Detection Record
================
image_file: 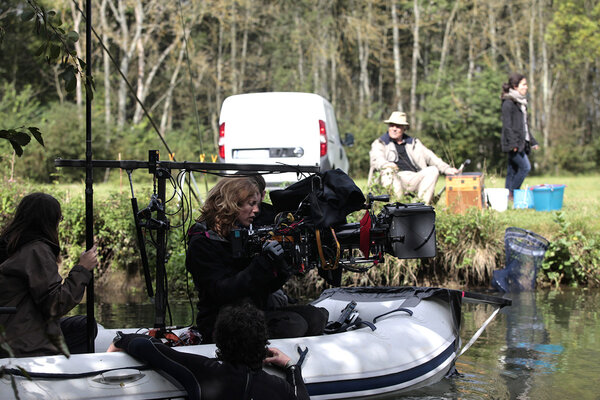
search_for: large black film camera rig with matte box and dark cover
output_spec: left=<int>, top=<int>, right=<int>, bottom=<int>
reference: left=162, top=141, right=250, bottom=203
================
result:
left=231, top=170, right=436, bottom=285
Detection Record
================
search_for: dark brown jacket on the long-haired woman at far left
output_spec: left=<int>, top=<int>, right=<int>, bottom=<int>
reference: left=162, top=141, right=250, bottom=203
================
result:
left=0, top=240, right=92, bottom=357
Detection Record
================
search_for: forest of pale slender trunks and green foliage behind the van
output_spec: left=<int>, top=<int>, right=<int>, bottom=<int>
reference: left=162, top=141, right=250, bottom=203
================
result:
left=0, top=0, right=600, bottom=296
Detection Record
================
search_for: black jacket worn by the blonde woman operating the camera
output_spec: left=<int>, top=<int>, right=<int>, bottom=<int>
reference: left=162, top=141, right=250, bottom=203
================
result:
left=185, top=223, right=288, bottom=343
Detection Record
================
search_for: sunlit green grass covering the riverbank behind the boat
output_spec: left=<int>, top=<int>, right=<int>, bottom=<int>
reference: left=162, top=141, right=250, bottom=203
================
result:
left=10, top=171, right=600, bottom=290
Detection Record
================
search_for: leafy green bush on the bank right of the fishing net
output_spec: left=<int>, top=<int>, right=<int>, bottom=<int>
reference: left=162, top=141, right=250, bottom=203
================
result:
left=542, top=212, right=600, bottom=286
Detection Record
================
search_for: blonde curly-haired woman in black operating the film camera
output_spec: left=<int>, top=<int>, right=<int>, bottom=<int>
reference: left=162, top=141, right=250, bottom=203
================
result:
left=186, top=177, right=329, bottom=343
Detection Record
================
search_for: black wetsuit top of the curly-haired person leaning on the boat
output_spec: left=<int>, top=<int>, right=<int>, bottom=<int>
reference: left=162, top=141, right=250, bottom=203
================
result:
left=115, top=335, right=309, bottom=400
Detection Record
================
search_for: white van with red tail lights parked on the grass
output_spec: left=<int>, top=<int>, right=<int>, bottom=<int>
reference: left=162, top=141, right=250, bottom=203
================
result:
left=219, top=92, right=354, bottom=188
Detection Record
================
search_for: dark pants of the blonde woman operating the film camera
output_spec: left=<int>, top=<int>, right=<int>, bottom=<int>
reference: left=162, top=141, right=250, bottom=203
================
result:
left=265, top=305, right=329, bottom=339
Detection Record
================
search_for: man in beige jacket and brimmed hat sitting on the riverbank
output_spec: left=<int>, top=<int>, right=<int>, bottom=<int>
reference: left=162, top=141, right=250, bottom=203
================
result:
left=369, top=111, right=458, bottom=204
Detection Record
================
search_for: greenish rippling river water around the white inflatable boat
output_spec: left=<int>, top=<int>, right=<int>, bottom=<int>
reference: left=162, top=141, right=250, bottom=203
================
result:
left=79, top=289, right=600, bottom=400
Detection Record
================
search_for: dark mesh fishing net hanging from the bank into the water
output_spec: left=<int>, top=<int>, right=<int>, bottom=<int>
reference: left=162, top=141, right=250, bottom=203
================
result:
left=492, top=227, right=549, bottom=292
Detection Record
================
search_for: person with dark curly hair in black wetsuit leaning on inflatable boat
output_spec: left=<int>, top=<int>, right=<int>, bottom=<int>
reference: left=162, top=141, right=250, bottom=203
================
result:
left=108, top=304, right=309, bottom=400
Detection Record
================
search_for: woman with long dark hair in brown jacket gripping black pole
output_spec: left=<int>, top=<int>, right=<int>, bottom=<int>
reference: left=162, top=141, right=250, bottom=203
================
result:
left=0, top=193, right=98, bottom=357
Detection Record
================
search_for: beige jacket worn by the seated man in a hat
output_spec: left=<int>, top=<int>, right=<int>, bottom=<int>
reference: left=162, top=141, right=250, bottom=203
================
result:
left=369, top=132, right=450, bottom=174
